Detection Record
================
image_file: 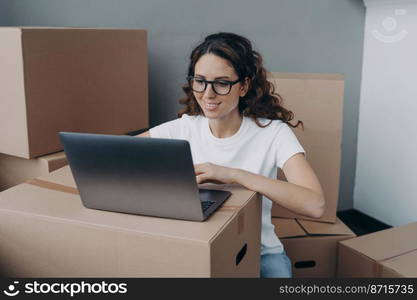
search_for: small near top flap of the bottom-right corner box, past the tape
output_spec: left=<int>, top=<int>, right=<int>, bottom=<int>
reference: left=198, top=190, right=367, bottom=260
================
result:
left=381, top=251, right=417, bottom=278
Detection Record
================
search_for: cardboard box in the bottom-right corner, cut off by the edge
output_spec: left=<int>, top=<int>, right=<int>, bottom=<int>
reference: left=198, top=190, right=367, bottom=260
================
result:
left=337, top=222, right=417, bottom=278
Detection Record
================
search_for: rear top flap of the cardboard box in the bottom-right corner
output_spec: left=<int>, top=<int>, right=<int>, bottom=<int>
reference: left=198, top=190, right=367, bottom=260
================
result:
left=341, top=222, right=417, bottom=261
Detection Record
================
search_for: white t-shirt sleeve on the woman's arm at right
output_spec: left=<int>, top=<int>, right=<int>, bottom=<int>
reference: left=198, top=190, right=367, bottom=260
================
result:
left=276, top=124, right=306, bottom=169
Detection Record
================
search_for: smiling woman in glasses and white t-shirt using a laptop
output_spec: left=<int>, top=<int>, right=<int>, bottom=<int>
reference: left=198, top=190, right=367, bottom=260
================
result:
left=140, top=33, right=325, bottom=277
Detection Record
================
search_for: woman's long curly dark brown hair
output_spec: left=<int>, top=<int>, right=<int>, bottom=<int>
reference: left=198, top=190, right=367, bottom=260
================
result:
left=178, top=32, right=304, bottom=129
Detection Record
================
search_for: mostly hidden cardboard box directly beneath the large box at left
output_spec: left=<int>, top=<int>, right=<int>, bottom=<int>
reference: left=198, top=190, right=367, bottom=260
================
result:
left=0, top=151, right=68, bottom=192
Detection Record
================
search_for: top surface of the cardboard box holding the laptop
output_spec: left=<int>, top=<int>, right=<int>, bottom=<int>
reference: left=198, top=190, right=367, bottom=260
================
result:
left=0, top=166, right=257, bottom=243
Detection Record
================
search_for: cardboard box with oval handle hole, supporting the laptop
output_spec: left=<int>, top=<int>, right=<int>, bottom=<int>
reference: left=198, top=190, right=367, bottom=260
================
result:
left=0, top=166, right=261, bottom=277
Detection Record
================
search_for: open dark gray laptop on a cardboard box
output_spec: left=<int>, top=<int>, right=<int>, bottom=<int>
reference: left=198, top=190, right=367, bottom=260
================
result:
left=59, top=132, right=231, bottom=221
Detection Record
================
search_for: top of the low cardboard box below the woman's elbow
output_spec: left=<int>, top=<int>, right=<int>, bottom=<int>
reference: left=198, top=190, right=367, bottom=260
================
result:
left=272, top=218, right=355, bottom=238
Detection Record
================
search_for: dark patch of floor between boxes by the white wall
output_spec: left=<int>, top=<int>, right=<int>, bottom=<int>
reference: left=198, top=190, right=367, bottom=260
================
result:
left=337, top=209, right=392, bottom=236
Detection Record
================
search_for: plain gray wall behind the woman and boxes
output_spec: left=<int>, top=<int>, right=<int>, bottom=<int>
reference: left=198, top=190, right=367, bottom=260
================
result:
left=2, top=0, right=365, bottom=210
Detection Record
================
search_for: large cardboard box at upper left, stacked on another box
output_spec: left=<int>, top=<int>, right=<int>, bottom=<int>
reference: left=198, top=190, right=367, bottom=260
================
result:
left=0, top=27, right=149, bottom=158
